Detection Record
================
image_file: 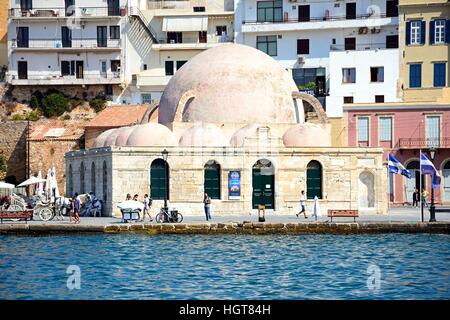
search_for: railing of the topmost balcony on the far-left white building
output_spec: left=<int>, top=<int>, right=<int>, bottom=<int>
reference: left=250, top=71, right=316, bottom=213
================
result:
left=9, top=6, right=127, bottom=18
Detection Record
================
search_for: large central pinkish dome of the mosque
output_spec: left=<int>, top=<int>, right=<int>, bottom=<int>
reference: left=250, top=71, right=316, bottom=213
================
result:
left=158, top=44, right=304, bottom=123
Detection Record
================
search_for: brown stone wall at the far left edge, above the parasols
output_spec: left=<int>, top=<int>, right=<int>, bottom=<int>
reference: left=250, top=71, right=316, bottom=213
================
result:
left=0, top=121, right=27, bottom=182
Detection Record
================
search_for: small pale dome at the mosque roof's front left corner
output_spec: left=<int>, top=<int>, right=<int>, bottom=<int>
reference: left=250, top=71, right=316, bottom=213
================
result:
left=126, top=123, right=178, bottom=147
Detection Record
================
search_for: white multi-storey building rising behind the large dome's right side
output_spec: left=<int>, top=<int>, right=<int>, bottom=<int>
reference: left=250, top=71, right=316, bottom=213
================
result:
left=235, top=0, right=398, bottom=117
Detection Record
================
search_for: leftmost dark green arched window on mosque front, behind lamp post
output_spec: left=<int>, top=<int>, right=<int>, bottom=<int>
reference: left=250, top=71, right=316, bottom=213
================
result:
left=150, top=159, right=170, bottom=200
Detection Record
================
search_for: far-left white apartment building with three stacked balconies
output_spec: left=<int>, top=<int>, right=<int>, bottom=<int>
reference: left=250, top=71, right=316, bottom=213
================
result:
left=7, top=0, right=127, bottom=95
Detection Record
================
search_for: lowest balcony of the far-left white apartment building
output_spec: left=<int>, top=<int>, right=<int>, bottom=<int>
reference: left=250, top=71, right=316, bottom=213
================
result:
left=6, top=72, right=122, bottom=86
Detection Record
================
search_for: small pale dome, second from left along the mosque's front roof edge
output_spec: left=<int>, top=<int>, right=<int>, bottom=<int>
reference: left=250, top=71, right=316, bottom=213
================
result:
left=180, top=123, right=230, bottom=147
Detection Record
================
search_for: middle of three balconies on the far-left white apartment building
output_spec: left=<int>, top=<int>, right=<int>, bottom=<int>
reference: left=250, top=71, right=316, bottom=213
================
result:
left=11, top=38, right=122, bottom=52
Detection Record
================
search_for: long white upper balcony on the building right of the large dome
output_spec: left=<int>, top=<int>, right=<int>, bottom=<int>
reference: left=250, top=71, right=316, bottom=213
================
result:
left=242, top=14, right=398, bottom=33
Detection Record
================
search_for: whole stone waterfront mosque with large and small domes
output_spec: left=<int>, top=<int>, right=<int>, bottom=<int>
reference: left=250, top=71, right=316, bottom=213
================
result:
left=66, top=44, right=387, bottom=216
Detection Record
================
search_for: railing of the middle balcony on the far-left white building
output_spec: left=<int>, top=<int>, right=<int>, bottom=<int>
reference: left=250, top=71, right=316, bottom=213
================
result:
left=11, top=38, right=121, bottom=49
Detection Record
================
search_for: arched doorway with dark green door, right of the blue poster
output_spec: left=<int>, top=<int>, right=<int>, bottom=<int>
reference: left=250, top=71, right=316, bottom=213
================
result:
left=252, top=159, right=275, bottom=209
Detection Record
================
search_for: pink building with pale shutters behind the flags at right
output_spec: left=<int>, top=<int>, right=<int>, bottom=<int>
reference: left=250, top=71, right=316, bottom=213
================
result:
left=344, top=103, right=450, bottom=205
